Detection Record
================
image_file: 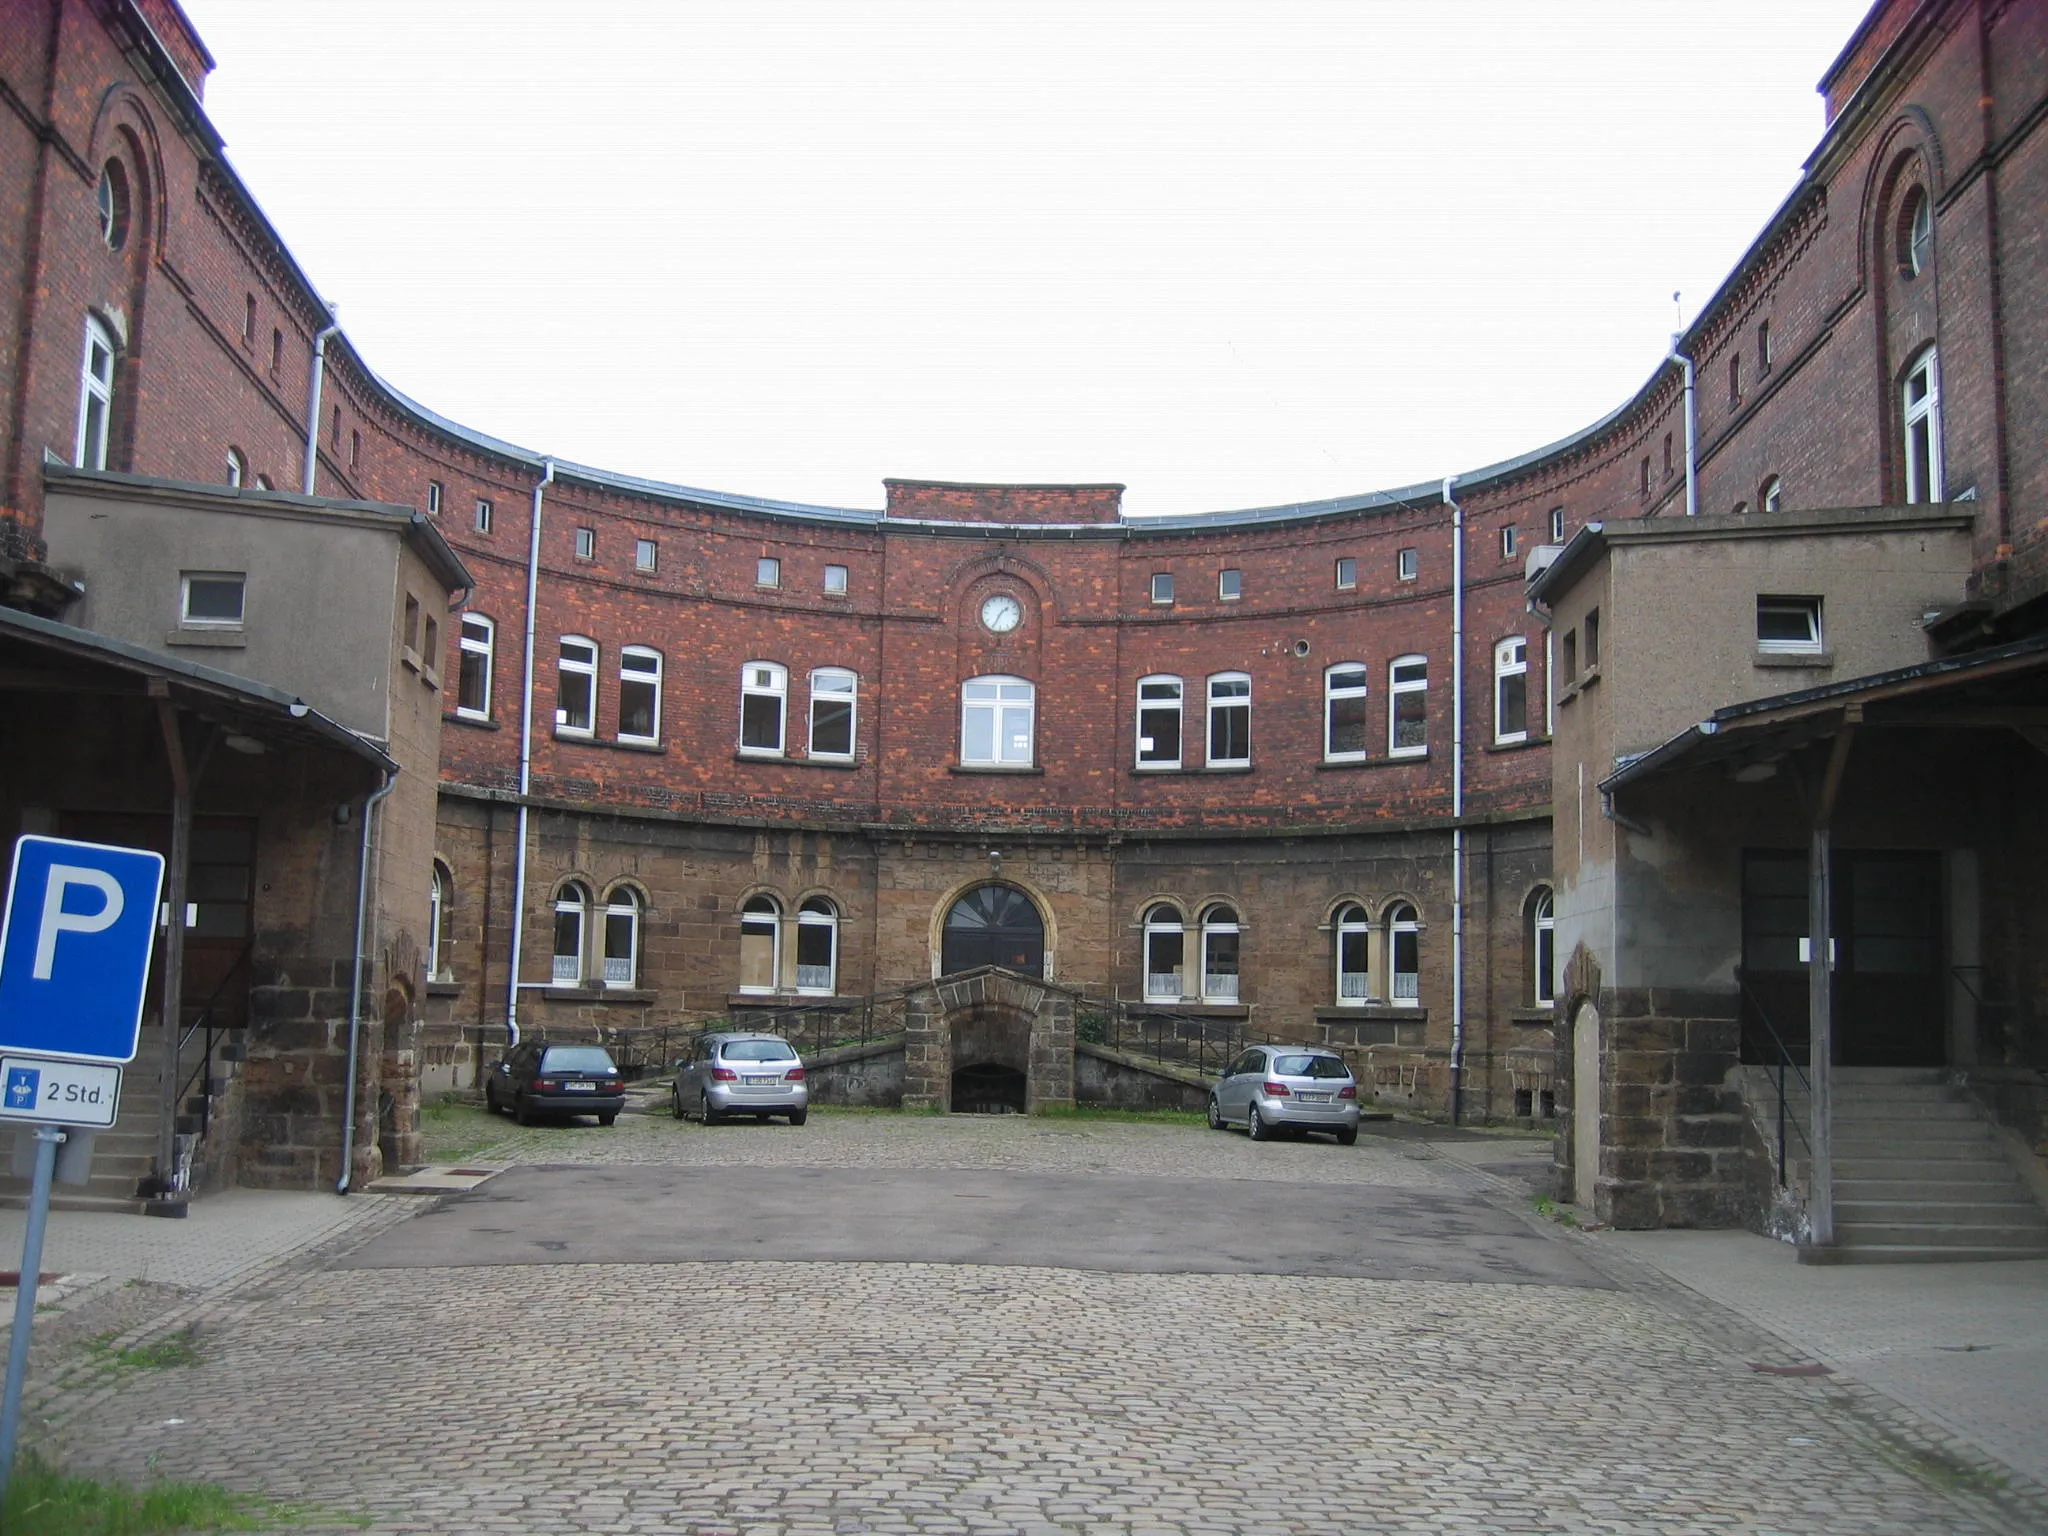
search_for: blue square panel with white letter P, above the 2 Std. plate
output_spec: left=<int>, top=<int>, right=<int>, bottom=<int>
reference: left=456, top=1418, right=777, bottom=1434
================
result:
left=0, top=836, right=164, bottom=1094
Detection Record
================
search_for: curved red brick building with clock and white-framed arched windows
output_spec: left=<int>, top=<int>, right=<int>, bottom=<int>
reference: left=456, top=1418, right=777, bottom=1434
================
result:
left=0, top=0, right=2048, bottom=1179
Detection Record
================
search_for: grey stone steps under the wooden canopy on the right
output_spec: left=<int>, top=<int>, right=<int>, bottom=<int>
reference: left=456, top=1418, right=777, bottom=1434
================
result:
left=1835, top=1067, right=2048, bottom=1264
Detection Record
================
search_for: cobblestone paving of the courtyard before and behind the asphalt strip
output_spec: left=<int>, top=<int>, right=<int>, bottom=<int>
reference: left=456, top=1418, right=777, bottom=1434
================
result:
left=19, top=1114, right=2040, bottom=1536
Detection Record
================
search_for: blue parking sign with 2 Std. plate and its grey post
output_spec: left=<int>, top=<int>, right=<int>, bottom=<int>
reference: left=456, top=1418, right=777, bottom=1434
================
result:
left=0, top=836, right=163, bottom=1495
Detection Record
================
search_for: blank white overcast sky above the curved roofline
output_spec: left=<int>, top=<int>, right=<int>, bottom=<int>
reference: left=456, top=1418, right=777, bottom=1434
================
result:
left=184, top=0, right=1868, bottom=512
